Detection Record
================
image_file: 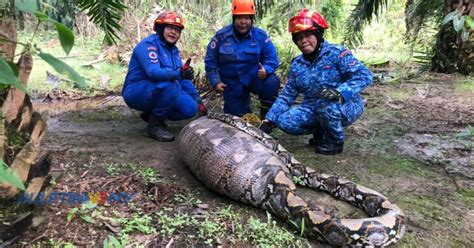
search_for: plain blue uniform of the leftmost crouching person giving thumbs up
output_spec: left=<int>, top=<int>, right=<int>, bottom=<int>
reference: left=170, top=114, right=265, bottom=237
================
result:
left=122, top=34, right=200, bottom=120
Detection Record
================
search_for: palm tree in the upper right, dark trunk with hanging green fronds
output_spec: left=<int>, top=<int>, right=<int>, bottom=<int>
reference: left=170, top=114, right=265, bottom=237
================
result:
left=344, top=0, right=474, bottom=75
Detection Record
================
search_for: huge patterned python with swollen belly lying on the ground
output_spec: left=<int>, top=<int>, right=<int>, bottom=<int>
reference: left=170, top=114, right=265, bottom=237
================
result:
left=178, top=112, right=405, bottom=247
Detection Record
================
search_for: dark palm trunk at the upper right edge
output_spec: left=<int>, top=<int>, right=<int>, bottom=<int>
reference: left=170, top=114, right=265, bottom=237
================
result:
left=432, top=0, right=474, bottom=75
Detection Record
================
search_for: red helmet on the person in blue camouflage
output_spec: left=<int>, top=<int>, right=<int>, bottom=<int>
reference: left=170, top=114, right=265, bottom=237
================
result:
left=288, top=9, right=328, bottom=34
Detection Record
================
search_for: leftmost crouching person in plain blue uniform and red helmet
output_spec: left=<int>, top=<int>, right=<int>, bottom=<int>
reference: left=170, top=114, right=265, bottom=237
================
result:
left=122, top=11, right=205, bottom=142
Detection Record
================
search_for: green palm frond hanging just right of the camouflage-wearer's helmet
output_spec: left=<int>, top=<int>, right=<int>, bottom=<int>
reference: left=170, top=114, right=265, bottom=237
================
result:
left=344, top=0, right=388, bottom=48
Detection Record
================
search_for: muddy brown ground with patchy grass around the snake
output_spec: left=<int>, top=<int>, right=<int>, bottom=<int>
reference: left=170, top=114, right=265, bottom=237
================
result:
left=8, top=74, right=474, bottom=247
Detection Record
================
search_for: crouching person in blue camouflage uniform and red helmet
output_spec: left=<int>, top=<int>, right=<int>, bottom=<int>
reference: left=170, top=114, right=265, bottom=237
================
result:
left=260, top=9, right=372, bottom=155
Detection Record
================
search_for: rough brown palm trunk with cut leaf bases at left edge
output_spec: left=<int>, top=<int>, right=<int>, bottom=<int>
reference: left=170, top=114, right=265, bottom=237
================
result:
left=0, top=18, right=46, bottom=199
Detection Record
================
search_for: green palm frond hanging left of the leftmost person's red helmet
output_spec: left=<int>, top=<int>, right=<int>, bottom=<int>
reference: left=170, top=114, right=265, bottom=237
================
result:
left=77, top=0, right=127, bottom=45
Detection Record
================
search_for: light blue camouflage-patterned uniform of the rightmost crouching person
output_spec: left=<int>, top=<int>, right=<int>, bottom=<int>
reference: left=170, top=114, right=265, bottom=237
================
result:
left=266, top=41, right=372, bottom=144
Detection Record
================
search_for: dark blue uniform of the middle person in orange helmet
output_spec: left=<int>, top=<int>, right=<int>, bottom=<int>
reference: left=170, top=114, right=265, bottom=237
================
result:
left=205, top=25, right=280, bottom=116
